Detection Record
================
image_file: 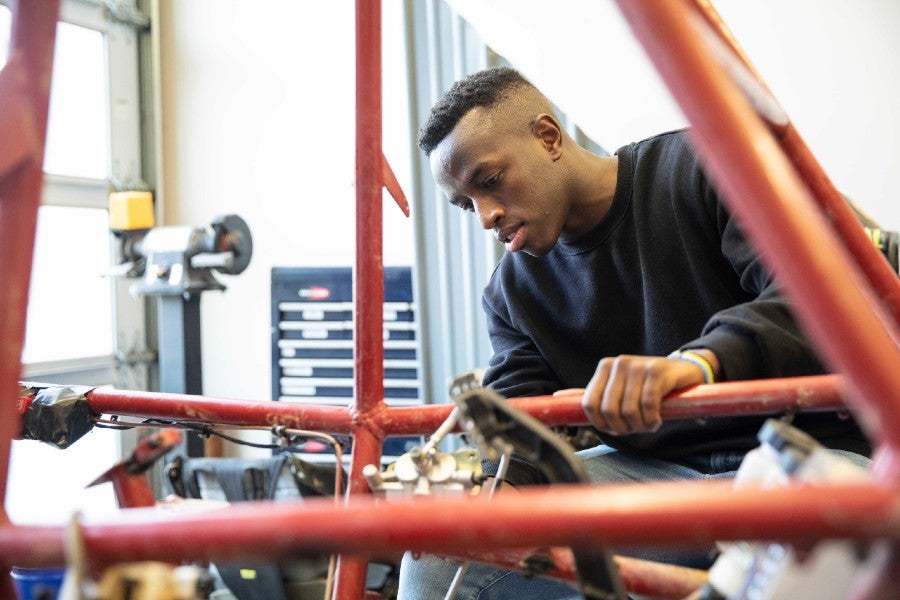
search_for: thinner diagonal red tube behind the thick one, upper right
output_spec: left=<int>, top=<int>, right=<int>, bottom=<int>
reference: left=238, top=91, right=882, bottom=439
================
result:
left=694, top=0, right=900, bottom=323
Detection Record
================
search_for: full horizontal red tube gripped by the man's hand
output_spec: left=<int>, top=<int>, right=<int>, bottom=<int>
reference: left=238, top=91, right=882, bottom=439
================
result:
left=75, top=375, right=846, bottom=438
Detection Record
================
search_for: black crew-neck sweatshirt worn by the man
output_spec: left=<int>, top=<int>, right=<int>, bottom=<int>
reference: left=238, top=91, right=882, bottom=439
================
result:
left=483, top=131, right=869, bottom=458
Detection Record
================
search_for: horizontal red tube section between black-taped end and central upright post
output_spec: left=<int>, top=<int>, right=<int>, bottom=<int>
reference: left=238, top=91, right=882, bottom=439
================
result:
left=86, top=388, right=353, bottom=433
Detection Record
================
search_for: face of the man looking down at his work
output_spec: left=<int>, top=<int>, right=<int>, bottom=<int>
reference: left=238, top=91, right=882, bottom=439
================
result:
left=430, top=108, right=566, bottom=256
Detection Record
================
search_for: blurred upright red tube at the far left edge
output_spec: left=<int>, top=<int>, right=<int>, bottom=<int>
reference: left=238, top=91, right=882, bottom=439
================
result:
left=0, top=0, right=59, bottom=520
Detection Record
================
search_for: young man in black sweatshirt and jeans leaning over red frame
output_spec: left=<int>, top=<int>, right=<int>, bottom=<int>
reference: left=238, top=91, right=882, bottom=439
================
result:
left=401, top=68, right=869, bottom=598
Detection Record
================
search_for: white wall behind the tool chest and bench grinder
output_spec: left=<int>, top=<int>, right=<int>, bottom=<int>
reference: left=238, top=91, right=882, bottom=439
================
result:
left=158, top=0, right=413, bottom=426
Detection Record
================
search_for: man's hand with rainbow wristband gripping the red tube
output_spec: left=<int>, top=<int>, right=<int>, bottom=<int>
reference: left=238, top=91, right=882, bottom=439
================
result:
left=581, top=350, right=719, bottom=435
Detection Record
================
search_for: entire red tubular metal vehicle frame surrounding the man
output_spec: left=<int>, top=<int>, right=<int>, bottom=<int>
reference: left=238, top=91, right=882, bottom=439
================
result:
left=0, top=0, right=900, bottom=600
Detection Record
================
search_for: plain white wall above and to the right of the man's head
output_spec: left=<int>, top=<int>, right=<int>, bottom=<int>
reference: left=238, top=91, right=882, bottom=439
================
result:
left=448, top=0, right=900, bottom=229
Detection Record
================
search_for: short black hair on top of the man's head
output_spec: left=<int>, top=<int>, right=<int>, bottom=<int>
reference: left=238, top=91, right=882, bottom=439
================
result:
left=419, top=67, right=534, bottom=156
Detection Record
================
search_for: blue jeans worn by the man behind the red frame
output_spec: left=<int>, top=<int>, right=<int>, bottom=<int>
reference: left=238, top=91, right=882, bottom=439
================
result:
left=398, top=446, right=868, bottom=600
